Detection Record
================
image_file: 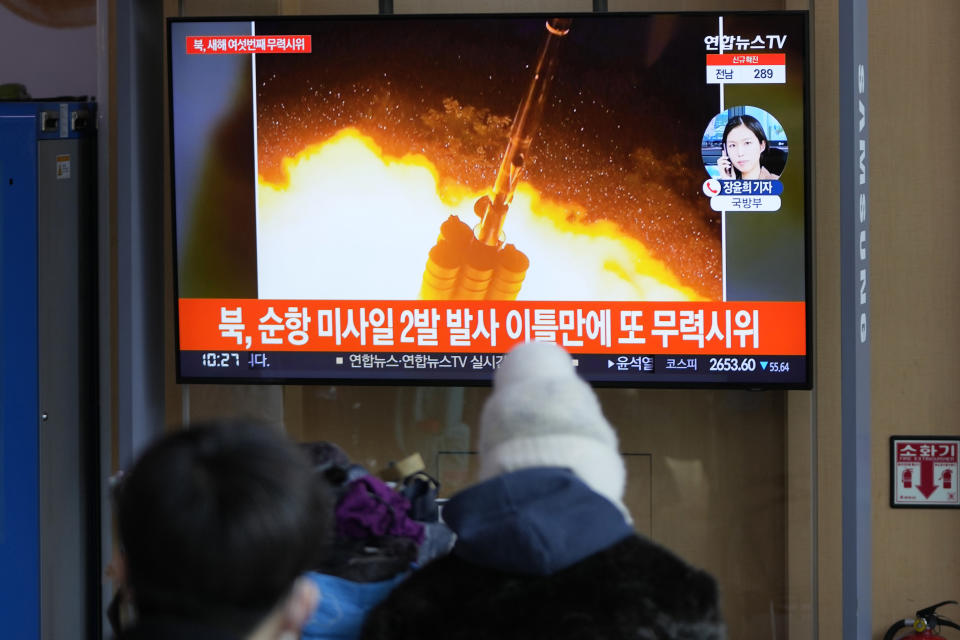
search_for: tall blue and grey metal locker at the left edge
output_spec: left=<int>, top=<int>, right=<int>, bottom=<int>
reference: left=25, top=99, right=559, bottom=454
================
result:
left=0, top=102, right=99, bottom=639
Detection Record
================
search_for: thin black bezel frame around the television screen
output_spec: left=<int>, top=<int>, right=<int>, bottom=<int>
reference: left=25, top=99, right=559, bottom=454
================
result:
left=164, top=9, right=815, bottom=391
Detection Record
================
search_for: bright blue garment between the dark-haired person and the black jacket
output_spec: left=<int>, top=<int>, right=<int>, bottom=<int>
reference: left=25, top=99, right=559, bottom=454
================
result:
left=301, top=571, right=409, bottom=640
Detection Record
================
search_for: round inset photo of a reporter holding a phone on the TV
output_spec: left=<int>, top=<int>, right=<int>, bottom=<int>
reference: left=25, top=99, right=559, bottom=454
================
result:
left=700, top=106, right=789, bottom=180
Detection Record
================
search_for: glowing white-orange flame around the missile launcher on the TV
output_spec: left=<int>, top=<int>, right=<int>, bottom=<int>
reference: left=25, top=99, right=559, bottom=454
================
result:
left=257, top=128, right=703, bottom=301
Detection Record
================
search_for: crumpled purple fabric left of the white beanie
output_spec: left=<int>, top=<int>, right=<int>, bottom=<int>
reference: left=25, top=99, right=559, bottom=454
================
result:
left=336, top=475, right=424, bottom=544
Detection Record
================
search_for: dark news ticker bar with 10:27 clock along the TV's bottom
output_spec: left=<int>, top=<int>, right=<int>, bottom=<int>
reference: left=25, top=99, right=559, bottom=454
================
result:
left=180, top=351, right=807, bottom=385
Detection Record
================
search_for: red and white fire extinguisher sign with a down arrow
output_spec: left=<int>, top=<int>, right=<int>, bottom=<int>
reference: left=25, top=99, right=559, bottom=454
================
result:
left=890, top=436, right=960, bottom=509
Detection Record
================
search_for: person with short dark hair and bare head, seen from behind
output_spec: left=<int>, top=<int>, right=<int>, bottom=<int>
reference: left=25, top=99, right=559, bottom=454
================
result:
left=114, top=421, right=333, bottom=640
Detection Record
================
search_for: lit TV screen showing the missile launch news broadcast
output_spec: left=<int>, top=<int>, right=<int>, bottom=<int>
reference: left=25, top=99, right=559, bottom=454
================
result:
left=167, top=12, right=810, bottom=388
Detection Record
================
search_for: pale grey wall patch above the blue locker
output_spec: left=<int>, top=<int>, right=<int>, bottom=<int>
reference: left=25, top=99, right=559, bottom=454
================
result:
left=0, top=6, right=97, bottom=98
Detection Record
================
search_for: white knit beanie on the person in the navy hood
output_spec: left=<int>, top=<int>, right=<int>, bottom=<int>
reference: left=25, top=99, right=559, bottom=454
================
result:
left=479, top=342, right=630, bottom=520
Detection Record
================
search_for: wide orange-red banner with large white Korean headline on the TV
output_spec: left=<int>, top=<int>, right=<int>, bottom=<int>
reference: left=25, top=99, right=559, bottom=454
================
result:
left=179, top=299, right=806, bottom=356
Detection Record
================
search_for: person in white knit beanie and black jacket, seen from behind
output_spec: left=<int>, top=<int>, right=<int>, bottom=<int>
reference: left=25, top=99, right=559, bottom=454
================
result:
left=361, top=343, right=725, bottom=640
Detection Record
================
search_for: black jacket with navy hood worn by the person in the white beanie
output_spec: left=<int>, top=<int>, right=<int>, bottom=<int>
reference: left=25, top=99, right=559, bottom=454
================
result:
left=362, top=469, right=725, bottom=640
